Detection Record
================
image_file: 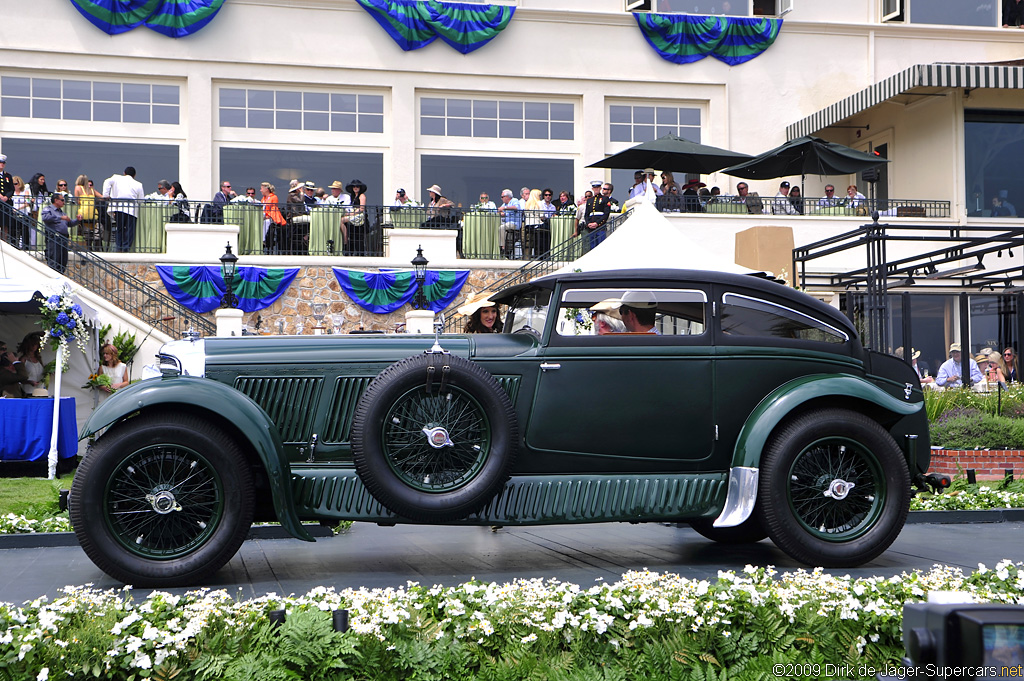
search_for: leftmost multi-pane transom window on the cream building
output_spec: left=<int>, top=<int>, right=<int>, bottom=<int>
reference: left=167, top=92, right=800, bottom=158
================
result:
left=0, top=76, right=180, bottom=125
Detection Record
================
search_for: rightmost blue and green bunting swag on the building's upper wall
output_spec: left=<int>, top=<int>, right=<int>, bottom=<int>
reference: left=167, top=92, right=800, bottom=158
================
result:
left=633, top=12, right=782, bottom=67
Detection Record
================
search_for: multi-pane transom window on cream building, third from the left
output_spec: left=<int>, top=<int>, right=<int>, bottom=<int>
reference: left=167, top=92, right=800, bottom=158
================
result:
left=420, top=97, right=575, bottom=139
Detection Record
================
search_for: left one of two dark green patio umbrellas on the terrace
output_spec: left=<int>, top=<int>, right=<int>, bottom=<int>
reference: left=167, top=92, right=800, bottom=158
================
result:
left=587, top=135, right=753, bottom=175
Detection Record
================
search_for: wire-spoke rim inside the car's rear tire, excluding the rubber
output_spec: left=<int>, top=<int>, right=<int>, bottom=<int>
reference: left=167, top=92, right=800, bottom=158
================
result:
left=788, top=437, right=886, bottom=542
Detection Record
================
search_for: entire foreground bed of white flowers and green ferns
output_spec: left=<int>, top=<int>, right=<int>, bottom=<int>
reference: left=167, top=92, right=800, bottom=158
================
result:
left=0, top=560, right=1024, bottom=681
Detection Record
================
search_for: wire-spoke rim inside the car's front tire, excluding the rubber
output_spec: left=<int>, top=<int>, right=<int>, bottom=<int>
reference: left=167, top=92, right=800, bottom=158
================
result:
left=103, top=444, right=224, bottom=558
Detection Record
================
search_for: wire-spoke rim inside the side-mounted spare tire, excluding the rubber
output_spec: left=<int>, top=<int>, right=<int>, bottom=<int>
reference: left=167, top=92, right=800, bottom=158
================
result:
left=381, top=387, right=490, bottom=492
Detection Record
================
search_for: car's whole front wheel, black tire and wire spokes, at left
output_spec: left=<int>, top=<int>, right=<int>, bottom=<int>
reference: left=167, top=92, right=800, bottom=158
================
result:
left=70, top=415, right=254, bottom=587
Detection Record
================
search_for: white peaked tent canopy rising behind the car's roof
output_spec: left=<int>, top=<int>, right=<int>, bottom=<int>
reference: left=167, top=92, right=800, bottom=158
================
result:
left=558, top=201, right=757, bottom=274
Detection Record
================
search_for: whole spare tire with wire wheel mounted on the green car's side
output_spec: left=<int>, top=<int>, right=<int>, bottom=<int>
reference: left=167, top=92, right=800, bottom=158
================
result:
left=352, top=352, right=519, bottom=521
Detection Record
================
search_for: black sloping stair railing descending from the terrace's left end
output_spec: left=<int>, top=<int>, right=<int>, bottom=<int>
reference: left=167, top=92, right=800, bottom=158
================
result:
left=0, top=203, right=216, bottom=338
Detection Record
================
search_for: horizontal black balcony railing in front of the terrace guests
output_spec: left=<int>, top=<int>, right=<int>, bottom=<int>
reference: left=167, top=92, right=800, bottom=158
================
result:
left=6, top=196, right=950, bottom=260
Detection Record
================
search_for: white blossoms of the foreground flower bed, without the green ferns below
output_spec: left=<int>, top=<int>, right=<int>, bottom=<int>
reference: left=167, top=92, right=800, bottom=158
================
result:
left=0, top=560, right=1024, bottom=679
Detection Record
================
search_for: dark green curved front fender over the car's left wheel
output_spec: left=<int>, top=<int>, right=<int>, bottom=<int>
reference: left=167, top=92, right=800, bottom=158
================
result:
left=79, top=376, right=314, bottom=542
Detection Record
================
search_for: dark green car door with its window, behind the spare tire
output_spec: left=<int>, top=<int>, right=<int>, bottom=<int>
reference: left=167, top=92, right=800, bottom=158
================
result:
left=525, top=284, right=715, bottom=471
